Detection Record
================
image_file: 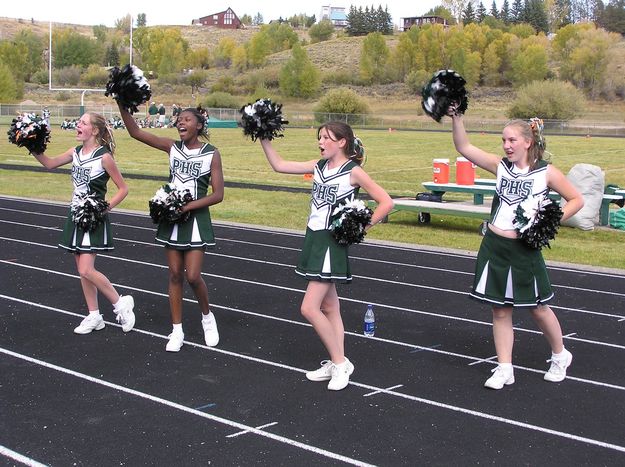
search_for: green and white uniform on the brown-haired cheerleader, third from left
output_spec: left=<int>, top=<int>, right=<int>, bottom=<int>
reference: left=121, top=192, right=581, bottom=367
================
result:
left=295, top=159, right=358, bottom=282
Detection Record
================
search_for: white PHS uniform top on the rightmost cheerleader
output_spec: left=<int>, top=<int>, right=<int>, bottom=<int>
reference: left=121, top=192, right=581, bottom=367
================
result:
left=490, top=158, right=549, bottom=230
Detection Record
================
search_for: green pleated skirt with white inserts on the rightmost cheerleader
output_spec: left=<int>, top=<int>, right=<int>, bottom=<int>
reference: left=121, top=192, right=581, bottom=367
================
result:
left=470, top=229, right=553, bottom=307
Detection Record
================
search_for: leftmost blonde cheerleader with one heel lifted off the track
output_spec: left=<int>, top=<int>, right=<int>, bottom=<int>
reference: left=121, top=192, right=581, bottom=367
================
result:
left=33, top=112, right=135, bottom=334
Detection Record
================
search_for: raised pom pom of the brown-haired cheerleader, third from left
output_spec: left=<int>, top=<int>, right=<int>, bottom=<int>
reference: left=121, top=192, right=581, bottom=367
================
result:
left=239, top=99, right=289, bottom=141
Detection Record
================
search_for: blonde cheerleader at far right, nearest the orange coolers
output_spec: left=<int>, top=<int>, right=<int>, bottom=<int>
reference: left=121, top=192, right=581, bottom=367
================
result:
left=449, top=107, right=584, bottom=389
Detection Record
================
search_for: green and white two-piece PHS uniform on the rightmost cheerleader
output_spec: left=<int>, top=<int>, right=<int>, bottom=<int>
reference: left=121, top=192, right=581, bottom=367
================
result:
left=471, top=158, right=553, bottom=307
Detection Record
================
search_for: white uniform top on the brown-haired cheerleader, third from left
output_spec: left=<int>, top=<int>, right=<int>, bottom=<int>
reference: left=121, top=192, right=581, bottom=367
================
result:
left=308, top=159, right=358, bottom=230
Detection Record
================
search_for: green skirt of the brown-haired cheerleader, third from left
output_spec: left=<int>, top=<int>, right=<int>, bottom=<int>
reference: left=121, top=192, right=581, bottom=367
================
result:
left=295, top=228, right=352, bottom=283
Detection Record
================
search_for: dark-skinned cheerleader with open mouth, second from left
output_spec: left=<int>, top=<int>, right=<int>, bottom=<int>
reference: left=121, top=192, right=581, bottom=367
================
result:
left=118, top=104, right=224, bottom=352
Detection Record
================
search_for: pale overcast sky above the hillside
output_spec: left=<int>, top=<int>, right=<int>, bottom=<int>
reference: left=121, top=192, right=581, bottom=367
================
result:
left=0, top=0, right=441, bottom=27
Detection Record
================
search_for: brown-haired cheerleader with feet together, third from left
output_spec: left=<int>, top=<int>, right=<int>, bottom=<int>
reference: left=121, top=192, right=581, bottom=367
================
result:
left=260, top=122, right=393, bottom=391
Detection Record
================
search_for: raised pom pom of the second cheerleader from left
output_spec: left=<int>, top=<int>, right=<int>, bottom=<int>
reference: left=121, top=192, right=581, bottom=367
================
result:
left=104, top=65, right=152, bottom=114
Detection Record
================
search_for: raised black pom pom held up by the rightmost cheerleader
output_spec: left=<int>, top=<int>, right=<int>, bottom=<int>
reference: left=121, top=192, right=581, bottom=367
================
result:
left=421, top=70, right=469, bottom=122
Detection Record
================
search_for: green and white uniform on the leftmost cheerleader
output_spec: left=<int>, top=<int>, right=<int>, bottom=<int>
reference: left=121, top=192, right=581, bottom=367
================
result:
left=59, top=146, right=113, bottom=253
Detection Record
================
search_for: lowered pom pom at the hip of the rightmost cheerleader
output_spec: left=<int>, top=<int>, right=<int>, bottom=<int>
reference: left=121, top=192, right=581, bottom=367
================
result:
left=513, top=196, right=562, bottom=250
